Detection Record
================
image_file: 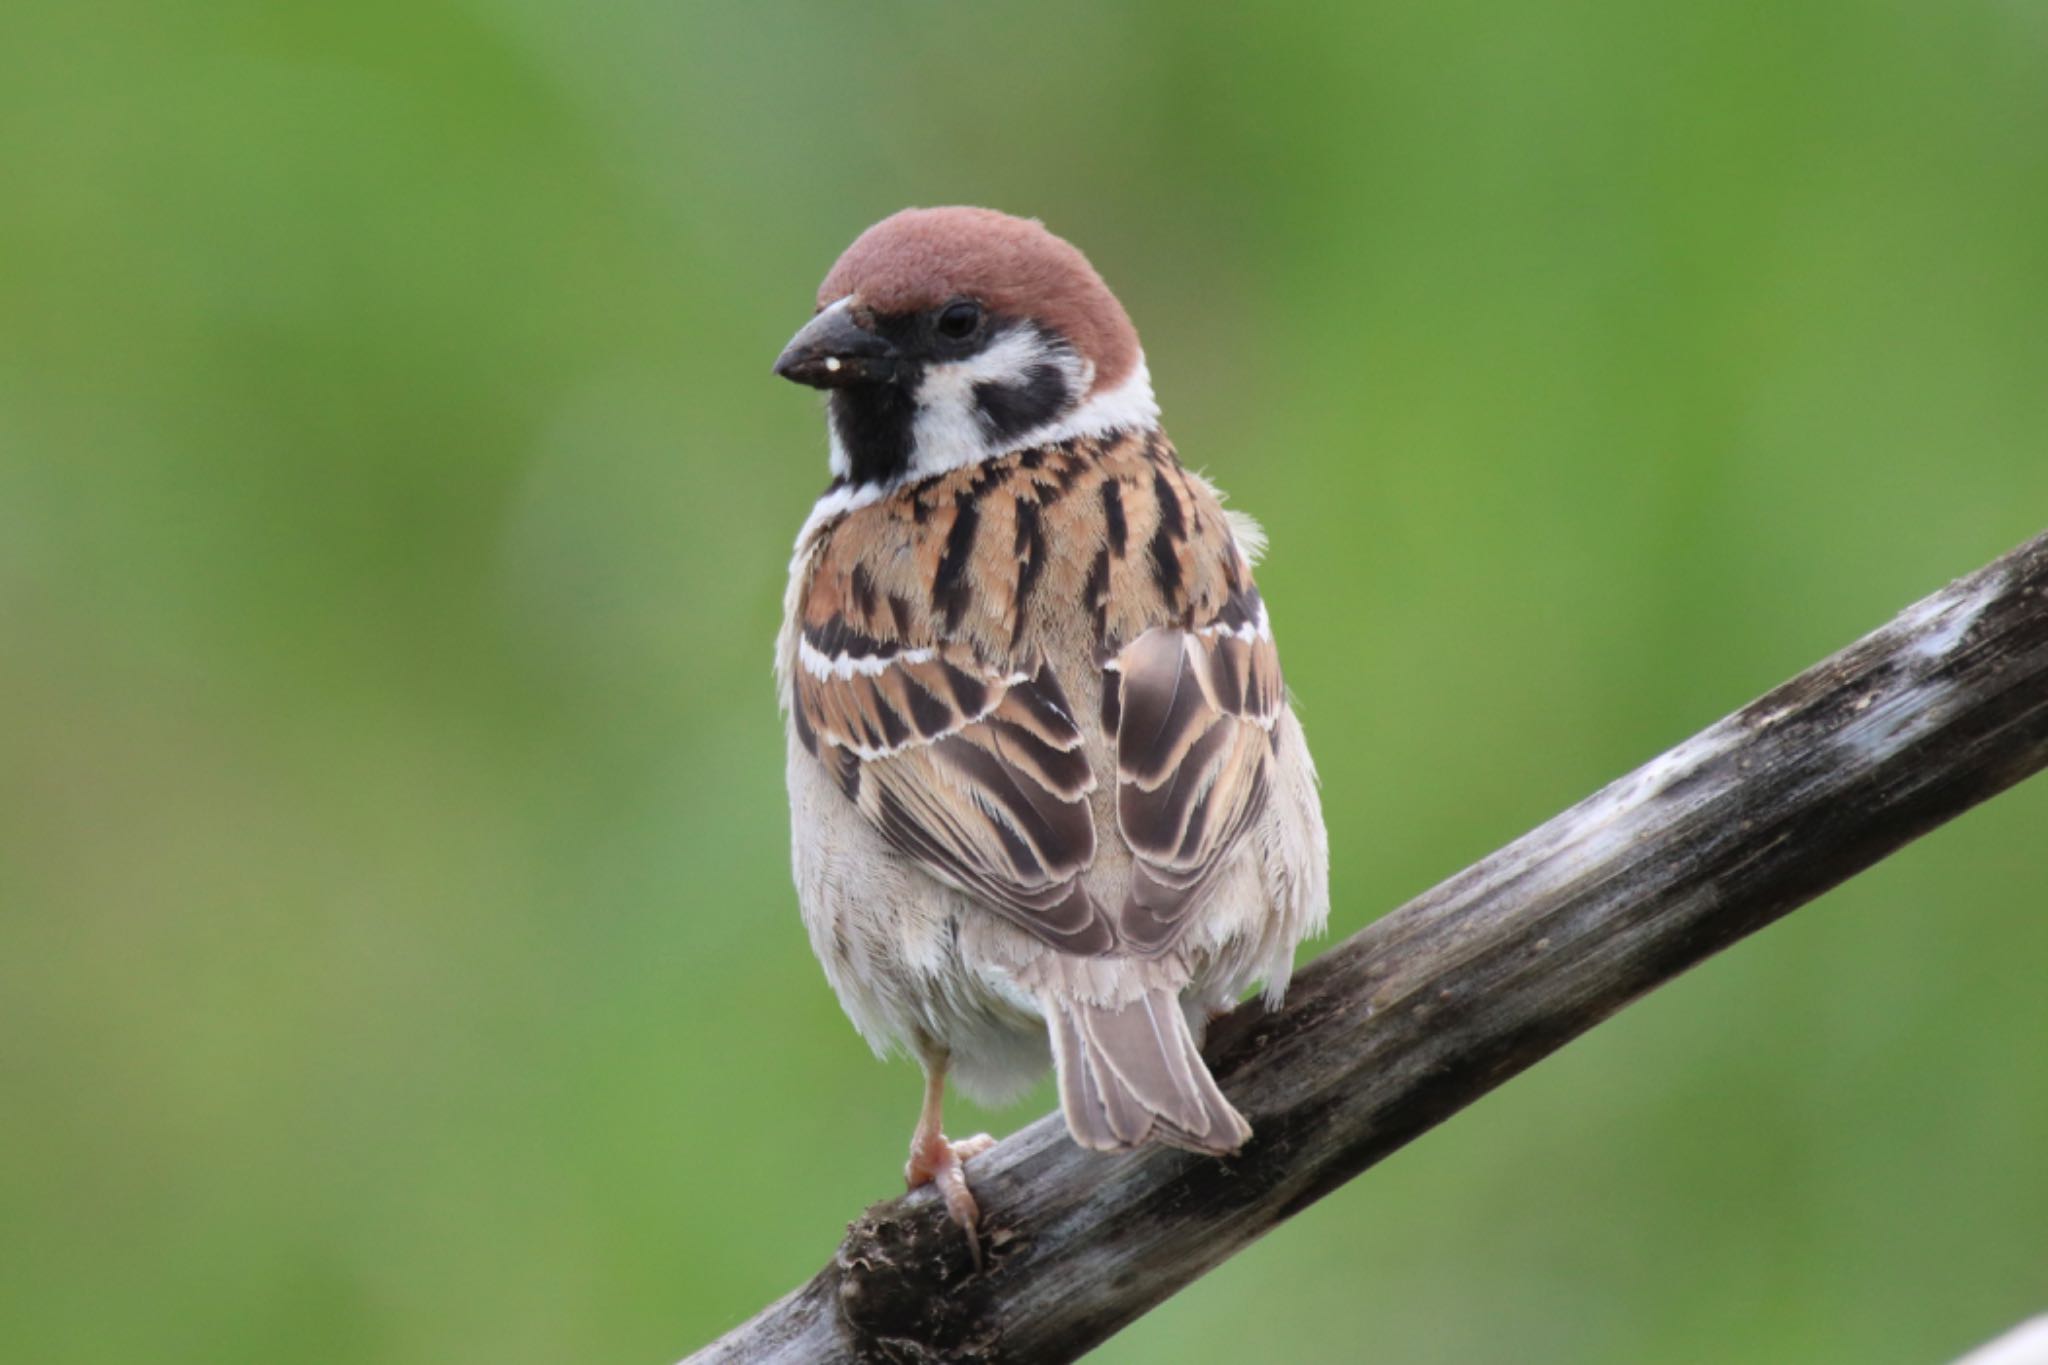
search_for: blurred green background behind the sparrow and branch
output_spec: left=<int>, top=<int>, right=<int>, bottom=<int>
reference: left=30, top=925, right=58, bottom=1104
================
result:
left=0, top=0, right=2048, bottom=1363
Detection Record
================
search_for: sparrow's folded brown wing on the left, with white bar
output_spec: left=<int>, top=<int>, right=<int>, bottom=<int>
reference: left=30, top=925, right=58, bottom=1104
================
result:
left=793, top=630, right=1116, bottom=954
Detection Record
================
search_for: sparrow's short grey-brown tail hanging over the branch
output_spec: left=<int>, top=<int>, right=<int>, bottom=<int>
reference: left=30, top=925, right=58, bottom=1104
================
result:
left=1047, top=988, right=1251, bottom=1154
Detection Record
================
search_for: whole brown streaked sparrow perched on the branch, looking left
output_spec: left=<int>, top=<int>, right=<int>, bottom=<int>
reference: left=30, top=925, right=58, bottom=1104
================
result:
left=774, top=207, right=1329, bottom=1265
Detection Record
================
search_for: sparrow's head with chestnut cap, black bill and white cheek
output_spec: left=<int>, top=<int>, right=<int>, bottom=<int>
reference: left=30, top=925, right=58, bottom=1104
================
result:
left=774, top=209, right=1159, bottom=487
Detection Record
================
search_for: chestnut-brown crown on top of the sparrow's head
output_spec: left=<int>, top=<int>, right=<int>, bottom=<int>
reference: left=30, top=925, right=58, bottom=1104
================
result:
left=817, top=209, right=1139, bottom=393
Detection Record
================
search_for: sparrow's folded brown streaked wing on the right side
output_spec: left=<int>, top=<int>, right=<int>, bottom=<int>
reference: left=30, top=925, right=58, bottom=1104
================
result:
left=1110, top=613, right=1284, bottom=956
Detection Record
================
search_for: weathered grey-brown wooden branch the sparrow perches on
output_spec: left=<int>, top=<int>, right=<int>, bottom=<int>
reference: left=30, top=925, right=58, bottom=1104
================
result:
left=692, top=534, right=2048, bottom=1365
